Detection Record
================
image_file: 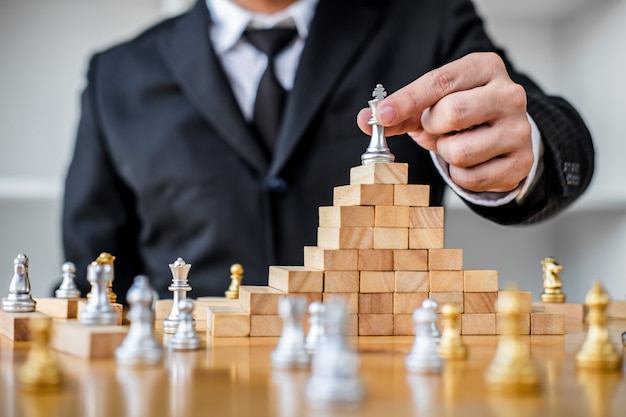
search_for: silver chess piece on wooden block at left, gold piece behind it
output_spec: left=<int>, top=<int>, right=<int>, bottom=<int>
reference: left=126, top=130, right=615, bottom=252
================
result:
left=78, top=262, right=117, bottom=325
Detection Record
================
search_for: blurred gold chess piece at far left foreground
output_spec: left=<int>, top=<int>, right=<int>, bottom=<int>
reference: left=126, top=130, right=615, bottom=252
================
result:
left=19, top=317, right=63, bottom=392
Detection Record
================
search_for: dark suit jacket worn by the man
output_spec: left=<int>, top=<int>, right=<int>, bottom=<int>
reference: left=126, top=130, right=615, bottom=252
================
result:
left=63, top=0, right=593, bottom=299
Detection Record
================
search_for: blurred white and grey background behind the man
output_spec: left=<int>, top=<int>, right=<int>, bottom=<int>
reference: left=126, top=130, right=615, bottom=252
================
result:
left=0, top=0, right=626, bottom=302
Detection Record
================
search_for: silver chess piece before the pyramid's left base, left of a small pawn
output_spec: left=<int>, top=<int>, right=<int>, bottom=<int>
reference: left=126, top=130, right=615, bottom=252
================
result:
left=271, top=296, right=310, bottom=368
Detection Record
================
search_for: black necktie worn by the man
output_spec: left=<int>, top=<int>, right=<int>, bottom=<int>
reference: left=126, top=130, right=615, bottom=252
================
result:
left=244, top=28, right=297, bottom=151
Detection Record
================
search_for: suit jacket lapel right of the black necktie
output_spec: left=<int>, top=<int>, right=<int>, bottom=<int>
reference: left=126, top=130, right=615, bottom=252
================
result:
left=270, top=0, right=387, bottom=176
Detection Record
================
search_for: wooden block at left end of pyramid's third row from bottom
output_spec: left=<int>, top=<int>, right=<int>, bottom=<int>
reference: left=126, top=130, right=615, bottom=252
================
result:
left=268, top=265, right=324, bottom=293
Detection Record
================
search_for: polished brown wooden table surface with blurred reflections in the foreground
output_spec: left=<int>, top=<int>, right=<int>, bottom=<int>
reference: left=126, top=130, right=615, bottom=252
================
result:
left=0, top=321, right=626, bottom=417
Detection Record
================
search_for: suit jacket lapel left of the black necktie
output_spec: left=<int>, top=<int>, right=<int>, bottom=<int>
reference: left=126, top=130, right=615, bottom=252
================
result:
left=161, top=0, right=268, bottom=175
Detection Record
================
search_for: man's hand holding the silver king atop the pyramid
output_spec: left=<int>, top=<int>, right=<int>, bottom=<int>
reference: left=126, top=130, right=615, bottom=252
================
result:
left=357, top=52, right=534, bottom=192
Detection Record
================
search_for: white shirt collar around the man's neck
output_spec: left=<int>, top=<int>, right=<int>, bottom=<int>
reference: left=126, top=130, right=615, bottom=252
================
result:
left=206, top=0, right=318, bottom=54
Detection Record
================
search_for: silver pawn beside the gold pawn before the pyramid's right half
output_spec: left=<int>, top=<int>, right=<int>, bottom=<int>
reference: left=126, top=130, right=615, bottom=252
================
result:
left=405, top=307, right=442, bottom=372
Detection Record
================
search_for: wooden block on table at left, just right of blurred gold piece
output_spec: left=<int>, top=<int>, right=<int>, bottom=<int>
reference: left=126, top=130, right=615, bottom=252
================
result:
left=50, top=321, right=128, bottom=359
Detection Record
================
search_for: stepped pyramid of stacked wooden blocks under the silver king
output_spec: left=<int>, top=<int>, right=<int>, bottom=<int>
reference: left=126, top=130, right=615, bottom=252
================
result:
left=207, top=163, right=565, bottom=336
